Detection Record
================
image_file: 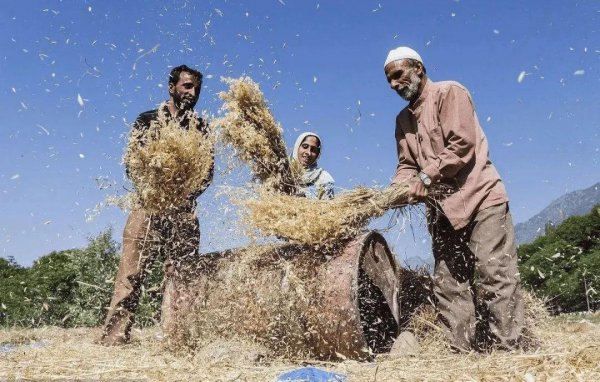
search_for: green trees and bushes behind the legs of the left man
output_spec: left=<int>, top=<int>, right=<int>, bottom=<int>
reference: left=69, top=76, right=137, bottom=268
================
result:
left=0, top=229, right=163, bottom=327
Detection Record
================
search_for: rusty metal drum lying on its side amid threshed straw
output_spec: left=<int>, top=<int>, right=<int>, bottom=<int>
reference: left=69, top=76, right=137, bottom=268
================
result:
left=163, top=231, right=410, bottom=360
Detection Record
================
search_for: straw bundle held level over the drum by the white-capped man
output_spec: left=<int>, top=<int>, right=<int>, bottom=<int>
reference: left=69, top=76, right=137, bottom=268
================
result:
left=236, top=185, right=407, bottom=244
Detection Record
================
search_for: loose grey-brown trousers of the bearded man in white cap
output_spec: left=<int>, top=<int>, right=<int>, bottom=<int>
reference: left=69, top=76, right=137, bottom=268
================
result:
left=429, top=203, right=523, bottom=350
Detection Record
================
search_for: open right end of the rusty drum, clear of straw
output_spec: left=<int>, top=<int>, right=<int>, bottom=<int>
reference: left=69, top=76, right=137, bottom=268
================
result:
left=314, top=231, right=400, bottom=360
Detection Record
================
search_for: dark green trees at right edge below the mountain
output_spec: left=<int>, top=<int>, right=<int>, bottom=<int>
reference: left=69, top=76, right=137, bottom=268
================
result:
left=519, top=206, right=600, bottom=312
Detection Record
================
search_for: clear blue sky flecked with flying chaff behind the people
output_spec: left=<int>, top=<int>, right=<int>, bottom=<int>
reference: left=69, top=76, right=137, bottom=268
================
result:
left=0, top=0, right=600, bottom=265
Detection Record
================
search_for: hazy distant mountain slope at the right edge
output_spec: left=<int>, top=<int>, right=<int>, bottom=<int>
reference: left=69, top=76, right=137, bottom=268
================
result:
left=515, top=183, right=600, bottom=244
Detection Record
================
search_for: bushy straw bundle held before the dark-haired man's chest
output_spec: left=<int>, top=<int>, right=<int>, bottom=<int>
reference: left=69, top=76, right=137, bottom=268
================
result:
left=124, top=105, right=214, bottom=212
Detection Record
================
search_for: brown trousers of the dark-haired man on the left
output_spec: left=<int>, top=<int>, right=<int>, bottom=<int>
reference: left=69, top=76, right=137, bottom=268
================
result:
left=100, top=210, right=200, bottom=345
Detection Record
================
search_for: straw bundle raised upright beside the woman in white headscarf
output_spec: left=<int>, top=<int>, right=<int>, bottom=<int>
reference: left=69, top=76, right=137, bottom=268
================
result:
left=215, top=77, right=295, bottom=194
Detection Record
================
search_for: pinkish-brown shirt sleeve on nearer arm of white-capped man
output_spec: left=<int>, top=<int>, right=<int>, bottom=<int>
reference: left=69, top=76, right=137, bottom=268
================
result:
left=423, top=85, right=477, bottom=182
